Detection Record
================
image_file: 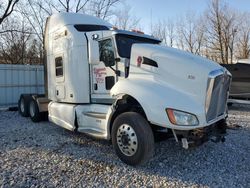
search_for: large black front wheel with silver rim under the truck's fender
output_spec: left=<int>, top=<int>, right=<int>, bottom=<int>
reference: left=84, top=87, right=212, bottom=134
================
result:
left=112, top=112, right=154, bottom=166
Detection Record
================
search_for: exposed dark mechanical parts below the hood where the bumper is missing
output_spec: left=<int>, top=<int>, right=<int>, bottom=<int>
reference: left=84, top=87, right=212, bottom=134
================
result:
left=173, top=119, right=227, bottom=149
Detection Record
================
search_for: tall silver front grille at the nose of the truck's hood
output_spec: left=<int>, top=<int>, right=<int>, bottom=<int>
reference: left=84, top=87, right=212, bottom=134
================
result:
left=206, top=69, right=231, bottom=122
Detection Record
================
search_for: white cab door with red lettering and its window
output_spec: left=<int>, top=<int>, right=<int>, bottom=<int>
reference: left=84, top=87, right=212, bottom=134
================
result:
left=88, top=32, right=117, bottom=103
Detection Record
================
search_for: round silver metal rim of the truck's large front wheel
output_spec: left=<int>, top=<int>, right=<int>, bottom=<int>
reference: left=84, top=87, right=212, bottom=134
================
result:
left=116, top=124, right=138, bottom=156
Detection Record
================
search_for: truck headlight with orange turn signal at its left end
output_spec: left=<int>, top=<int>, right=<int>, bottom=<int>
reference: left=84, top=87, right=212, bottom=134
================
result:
left=166, top=109, right=199, bottom=126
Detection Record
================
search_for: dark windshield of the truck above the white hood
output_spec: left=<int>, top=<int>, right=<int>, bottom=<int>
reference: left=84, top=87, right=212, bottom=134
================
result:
left=116, top=34, right=160, bottom=58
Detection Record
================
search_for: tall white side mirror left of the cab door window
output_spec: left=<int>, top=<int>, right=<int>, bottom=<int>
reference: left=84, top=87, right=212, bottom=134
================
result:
left=89, top=40, right=100, bottom=65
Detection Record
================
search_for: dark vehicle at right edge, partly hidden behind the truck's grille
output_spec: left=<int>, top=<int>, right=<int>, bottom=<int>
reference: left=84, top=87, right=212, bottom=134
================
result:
left=222, top=59, right=250, bottom=100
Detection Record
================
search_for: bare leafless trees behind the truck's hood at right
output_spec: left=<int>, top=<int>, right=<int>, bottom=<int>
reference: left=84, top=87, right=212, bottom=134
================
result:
left=152, top=0, right=250, bottom=64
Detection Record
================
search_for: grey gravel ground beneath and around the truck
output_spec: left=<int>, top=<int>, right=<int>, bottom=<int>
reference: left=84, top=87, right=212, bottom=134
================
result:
left=0, top=106, right=250, bottom=187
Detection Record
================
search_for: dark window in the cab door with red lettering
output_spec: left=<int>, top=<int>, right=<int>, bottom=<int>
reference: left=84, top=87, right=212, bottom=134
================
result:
left=99, top=39, right=115, bottom=67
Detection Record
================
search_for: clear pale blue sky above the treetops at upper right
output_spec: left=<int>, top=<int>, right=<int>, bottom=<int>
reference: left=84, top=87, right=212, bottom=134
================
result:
left=126, top=0, right=250, bottom=33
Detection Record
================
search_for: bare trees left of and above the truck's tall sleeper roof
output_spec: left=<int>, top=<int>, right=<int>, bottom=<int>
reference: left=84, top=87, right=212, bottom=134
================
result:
left=0, top=0, right=139, bottom=64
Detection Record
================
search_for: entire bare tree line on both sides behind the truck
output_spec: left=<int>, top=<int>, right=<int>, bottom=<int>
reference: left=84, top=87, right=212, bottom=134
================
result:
left=0, top=0, right=250, bottom=64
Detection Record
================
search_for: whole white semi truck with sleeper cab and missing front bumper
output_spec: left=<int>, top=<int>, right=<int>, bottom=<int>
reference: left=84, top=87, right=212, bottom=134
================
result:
left=19, top=13, right=231, bottom=165
